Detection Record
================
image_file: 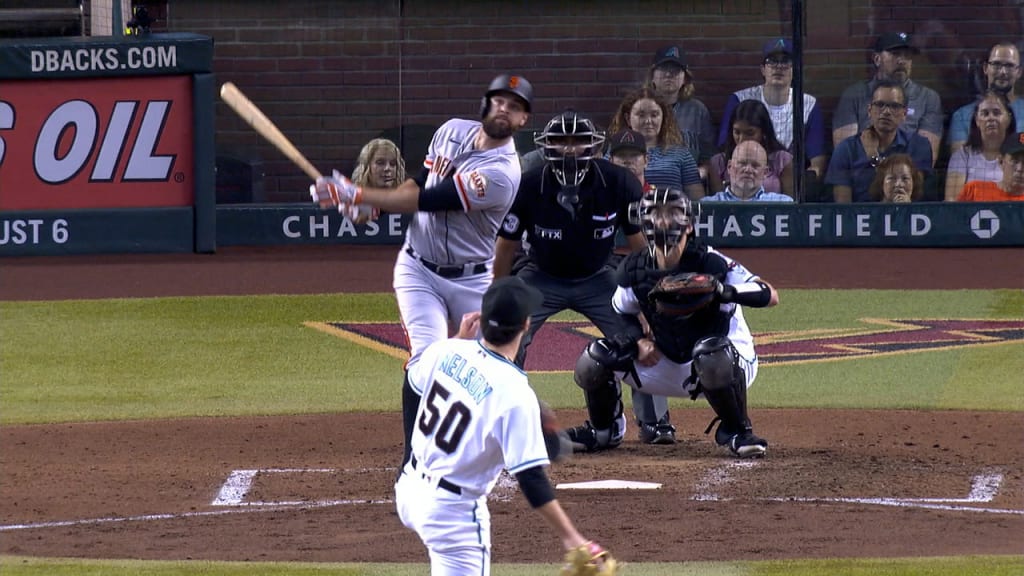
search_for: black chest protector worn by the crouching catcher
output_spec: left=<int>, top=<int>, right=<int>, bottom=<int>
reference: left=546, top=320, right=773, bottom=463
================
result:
left=621, top=243, right=735, bottom=364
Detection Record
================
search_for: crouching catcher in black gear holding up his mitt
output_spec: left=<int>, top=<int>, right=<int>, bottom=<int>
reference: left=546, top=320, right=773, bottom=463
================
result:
left=566, top=188, right=778, bottom=458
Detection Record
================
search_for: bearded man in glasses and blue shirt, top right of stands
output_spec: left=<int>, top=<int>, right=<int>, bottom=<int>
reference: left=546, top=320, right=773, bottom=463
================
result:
left=946, top=42, right=1024, bottom=151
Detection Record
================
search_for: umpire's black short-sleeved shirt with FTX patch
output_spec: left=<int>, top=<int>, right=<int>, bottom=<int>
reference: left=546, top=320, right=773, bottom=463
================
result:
left=498, top=158, right=643, bottom=278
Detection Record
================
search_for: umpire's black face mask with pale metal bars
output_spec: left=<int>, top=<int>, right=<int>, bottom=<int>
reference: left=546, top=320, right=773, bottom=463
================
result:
left=534, top=110, right=604, bottom=187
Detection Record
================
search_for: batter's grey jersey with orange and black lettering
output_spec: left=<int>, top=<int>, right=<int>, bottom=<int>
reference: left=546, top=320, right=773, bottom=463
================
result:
left=406, top=118, right=522, bottom=264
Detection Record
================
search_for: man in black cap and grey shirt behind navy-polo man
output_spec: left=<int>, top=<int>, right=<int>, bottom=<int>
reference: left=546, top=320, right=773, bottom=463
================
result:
left=833, top=32, right=942, bottom=165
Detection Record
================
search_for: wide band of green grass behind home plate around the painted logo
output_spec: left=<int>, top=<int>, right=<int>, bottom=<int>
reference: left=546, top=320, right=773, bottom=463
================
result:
left=0, top=290, right=1024, bottom=424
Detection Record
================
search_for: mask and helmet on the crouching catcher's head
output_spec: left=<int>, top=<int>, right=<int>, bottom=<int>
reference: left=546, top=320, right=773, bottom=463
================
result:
left=630, top=188, right=694, bottom=254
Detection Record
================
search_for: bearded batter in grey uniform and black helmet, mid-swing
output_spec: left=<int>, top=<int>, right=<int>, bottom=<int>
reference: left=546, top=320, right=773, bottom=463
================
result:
left=310, top=75, right=534, bottom=461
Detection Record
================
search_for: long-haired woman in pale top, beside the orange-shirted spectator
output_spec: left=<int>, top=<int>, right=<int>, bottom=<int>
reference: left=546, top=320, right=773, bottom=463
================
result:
left=945, top=88, right=1018, bottom=202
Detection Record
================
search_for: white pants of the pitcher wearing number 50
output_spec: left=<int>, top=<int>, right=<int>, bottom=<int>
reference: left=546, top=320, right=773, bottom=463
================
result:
left=394, top=464, right=490, bottom=576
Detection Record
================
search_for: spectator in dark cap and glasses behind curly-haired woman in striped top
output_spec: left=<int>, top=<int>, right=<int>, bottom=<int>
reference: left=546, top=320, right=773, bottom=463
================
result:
left=645, top=46, right=716, bottom=168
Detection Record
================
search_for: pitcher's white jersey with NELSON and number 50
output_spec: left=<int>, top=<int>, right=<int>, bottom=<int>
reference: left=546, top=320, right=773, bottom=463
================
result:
left=409, top=338, right=550, bottom=499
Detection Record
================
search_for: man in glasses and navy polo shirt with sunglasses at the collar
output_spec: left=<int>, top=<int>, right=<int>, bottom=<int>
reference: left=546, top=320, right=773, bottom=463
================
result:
left=825, top=80, right=932, bottom=203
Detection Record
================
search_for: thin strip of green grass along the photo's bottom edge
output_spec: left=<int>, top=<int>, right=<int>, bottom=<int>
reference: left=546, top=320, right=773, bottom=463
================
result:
left=0, top=557, right=1024, bottom=576
